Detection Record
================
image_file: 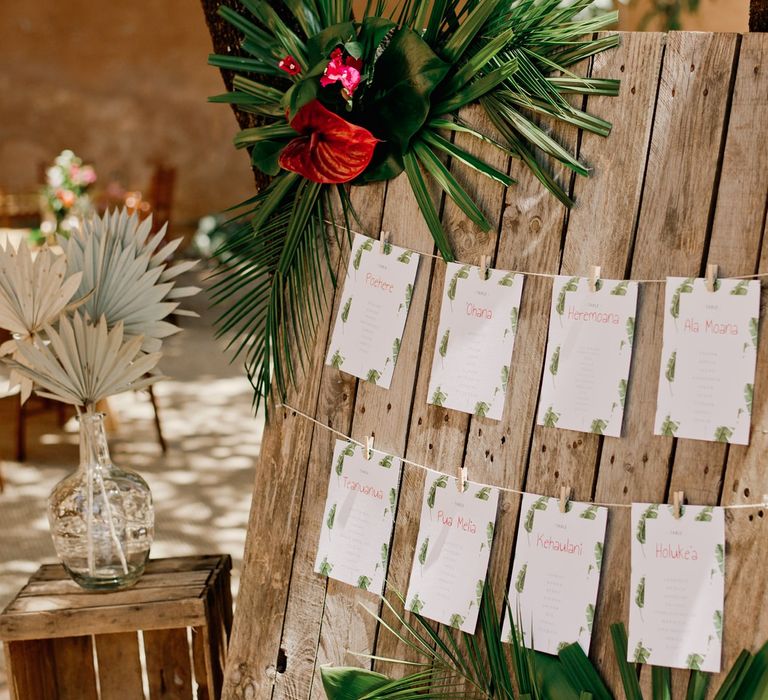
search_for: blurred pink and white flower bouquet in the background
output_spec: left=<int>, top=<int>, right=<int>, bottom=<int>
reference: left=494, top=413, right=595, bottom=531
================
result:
left=43, top=150, right=96, bottom=236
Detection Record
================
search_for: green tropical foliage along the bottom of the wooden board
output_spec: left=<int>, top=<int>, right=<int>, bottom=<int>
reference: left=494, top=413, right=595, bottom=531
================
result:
left=321, top=585, right=768, bottom=700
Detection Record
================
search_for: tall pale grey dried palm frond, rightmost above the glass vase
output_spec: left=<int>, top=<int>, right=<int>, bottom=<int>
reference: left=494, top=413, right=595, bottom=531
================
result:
left=61, top=209, right=200, bottom=352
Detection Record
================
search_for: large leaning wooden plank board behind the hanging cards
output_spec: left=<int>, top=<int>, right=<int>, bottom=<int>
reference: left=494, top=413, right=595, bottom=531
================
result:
left=213, top=32, right=768, bottom=700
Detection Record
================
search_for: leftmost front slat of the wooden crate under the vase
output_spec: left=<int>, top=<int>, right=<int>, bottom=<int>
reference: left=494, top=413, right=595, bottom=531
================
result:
left=3, top=639, right=58, bottom=700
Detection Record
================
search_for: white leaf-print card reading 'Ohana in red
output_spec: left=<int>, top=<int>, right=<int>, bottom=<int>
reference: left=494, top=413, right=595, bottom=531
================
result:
left=427, top=263, right=523, bottom=420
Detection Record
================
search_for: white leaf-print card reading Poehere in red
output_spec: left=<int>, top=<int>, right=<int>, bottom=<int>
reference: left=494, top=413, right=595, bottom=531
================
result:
left=325, top=233, right=419, bottom=389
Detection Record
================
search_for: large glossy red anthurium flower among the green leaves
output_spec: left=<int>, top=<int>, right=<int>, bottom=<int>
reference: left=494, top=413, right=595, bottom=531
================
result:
left=278, top=100, right=378, bottom=184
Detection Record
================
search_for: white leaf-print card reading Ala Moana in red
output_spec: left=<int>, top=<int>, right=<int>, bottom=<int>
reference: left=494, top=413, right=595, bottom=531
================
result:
left=654, top=277, right=760, bottom=445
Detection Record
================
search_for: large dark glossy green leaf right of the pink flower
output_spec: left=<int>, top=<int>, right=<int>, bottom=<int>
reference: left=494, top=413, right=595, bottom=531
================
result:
left=355, top=27, right=450, bottom=182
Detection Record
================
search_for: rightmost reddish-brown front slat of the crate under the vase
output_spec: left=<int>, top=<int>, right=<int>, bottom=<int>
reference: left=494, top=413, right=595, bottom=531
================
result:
left=143, top=627, right=192, bottom=700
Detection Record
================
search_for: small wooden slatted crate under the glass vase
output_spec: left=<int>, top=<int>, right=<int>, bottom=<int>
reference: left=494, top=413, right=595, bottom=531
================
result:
left=0, top=555, right=232, bottom=700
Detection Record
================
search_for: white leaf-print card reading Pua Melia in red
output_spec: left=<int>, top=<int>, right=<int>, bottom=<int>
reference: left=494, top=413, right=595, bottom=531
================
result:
left=406, top=470, right=499, bottom=634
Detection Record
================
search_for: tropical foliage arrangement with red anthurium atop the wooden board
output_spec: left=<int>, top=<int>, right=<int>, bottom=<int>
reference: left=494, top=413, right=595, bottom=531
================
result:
left=209, top=0, right=619, bottom=406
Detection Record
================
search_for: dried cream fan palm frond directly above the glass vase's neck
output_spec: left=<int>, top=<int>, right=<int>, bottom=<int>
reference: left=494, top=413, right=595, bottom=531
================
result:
left=6, top=311, right=161, bottom=408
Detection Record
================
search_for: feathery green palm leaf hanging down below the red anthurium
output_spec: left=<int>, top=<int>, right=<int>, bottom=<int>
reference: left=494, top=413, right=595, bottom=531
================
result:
left=211, top=175, right=344, bottom=416
